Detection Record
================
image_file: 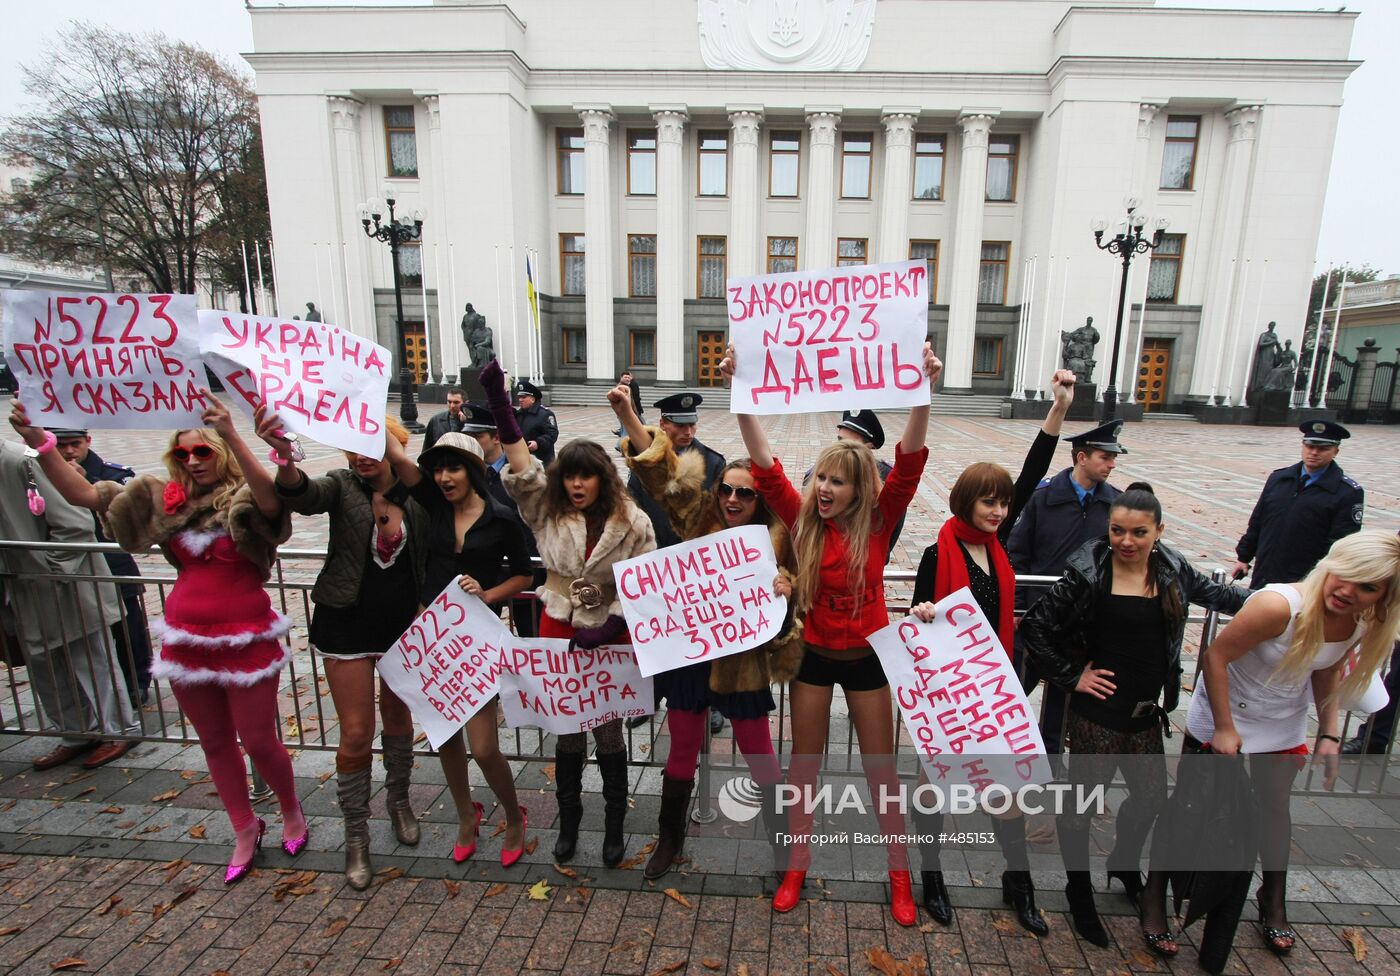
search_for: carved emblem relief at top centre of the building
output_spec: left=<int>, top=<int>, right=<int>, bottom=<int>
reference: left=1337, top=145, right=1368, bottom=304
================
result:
left=697, top=0, right=875, bottom=71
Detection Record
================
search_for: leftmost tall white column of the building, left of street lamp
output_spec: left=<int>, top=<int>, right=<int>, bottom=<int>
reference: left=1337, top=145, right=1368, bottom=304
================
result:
left=326, top=95, right=369, bottom=338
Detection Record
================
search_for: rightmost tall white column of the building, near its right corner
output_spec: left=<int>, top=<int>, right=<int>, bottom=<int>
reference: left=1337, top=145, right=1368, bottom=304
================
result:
left=1190, top=105, right=1263, bottom=403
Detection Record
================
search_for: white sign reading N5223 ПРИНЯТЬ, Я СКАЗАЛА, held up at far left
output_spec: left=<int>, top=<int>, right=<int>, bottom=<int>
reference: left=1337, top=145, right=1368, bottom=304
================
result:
left=0, top=290, right=209, bottom=428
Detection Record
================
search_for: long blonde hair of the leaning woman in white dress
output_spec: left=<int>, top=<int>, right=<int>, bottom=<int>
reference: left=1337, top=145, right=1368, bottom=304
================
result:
left=1271, top=531, right=1400, bottom=700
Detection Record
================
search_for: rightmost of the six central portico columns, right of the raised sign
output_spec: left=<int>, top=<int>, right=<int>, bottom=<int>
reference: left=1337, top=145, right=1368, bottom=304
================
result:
left=944, top=112, right=1009, bottom=393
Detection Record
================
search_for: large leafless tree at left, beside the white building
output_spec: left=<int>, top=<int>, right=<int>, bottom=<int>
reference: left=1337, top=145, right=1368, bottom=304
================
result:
left=0, top=24, right=267, bottom=293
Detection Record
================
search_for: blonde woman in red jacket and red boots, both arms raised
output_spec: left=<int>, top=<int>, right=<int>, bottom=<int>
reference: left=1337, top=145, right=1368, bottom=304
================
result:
left=720, top=343, right=944, bottom=926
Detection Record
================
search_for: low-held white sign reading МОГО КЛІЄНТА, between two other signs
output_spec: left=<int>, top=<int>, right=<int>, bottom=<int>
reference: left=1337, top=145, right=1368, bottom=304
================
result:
left=501, top=637, right=655, bottom=735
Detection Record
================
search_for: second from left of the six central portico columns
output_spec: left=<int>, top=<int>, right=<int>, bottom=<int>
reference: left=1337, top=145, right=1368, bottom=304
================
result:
left=652, top=105, right=686, bottom=382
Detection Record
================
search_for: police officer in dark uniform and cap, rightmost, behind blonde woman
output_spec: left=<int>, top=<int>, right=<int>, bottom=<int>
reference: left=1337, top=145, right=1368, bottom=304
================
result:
left=1235, top=420, right=1365, bottom=590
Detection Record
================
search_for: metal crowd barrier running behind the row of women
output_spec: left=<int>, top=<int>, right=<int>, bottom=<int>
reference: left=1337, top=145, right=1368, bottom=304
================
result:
left=0, top=539, right=1400, bottom=800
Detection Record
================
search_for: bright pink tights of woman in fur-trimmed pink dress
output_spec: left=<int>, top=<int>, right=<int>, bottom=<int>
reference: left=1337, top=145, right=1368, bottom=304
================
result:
left=171, top=674, right=301, bottom=837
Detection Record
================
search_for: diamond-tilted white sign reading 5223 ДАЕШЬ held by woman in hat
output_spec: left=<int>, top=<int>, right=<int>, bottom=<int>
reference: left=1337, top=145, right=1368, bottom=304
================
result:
left=377, top=577, right=512, bottom=749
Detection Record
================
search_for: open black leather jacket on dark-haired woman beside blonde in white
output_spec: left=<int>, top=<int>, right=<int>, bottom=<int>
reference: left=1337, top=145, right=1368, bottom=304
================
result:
left=1018, top=539, right=1249, bottom=711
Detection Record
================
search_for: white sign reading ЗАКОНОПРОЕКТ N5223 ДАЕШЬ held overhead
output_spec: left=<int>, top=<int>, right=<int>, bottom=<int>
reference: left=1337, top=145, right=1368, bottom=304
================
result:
left=725, top=260, right=928, bottom=413
